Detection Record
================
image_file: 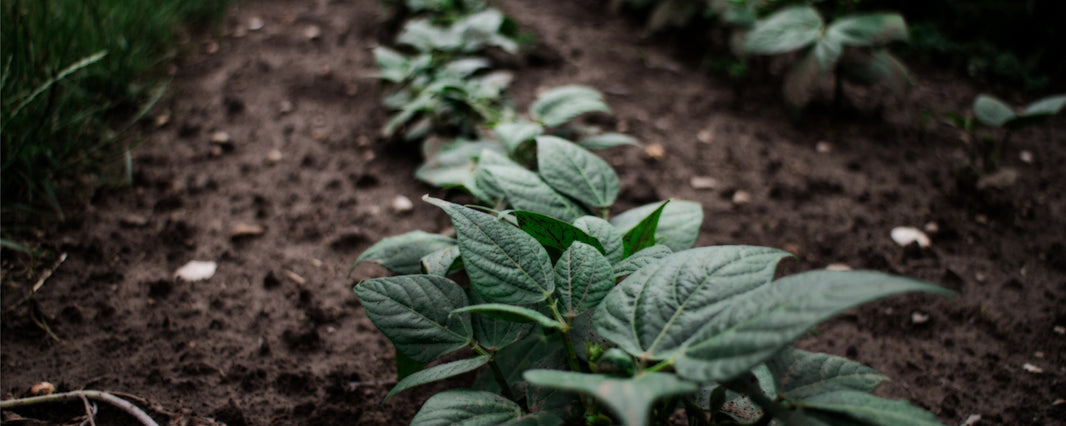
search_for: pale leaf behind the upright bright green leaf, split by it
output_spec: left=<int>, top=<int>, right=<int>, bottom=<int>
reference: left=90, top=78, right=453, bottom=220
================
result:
left=611, top=199, right=704, bottom=251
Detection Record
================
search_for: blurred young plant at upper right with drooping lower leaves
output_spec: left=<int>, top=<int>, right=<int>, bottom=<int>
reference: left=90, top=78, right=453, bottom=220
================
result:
left=743, top=6, right=910, bottom=110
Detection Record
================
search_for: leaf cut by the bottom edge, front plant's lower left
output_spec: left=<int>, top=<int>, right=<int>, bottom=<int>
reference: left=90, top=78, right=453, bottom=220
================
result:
left=410, top=389, right=522, bottom=426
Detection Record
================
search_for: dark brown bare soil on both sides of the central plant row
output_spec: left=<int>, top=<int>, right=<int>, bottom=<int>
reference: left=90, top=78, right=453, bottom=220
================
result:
left=0, top=0, right=1066, bottom=425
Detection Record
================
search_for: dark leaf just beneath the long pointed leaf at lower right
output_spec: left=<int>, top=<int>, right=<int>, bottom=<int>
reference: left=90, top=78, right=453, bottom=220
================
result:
left=766, top=347, right=888, bottom=400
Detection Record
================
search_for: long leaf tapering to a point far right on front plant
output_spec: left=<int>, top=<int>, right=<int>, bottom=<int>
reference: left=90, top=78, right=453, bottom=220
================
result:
left=673, top=269, right=951, bottom=381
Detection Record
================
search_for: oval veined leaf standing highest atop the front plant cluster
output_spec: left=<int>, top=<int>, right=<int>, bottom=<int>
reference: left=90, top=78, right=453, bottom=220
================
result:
left=536, top=136, right=619, bottom=209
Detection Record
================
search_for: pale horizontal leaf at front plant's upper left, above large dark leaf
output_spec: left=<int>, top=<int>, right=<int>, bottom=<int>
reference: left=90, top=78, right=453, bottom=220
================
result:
left=352, top=231, right=456, bottom=274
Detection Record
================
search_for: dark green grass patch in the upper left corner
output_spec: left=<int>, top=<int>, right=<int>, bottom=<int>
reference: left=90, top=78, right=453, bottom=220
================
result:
left=0, top=0, right=232, bottom=236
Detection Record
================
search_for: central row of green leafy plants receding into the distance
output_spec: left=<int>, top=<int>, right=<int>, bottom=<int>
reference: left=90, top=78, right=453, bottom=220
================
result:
left=353, top=1, right=950, bottom=425
